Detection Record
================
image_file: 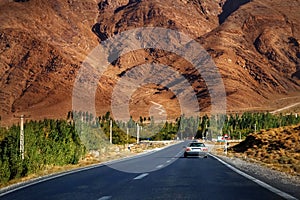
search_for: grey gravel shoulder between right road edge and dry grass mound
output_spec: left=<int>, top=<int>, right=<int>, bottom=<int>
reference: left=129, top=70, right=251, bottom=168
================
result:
left=215, top=155, right=300, bottom=199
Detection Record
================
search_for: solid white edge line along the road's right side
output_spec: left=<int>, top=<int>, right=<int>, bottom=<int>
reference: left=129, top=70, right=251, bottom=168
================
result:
left=210, top=154, right=297, bottom=200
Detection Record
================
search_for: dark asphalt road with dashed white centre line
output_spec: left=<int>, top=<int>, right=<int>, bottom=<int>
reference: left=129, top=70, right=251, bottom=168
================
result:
left=0, top=143, right=296, bottom=200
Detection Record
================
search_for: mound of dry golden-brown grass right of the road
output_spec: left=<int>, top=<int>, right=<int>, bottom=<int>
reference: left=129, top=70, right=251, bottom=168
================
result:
left=224, top=125, right=300, bottom=176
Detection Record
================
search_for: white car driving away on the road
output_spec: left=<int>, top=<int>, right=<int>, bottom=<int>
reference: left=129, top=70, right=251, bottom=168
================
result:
left=184, top=142, right=208, bottom=158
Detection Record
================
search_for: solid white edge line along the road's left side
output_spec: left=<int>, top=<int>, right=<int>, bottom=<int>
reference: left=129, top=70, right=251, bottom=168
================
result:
left=0, top=141, right=182, bottom=197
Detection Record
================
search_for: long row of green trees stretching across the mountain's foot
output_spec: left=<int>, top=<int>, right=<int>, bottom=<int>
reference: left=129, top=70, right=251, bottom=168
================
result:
left=0, top=112, right=300, bottom=184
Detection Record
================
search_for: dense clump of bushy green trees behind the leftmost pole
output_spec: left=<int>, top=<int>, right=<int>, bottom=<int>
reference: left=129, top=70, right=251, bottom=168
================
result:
left=0, top=120, right=85, bottom=184
